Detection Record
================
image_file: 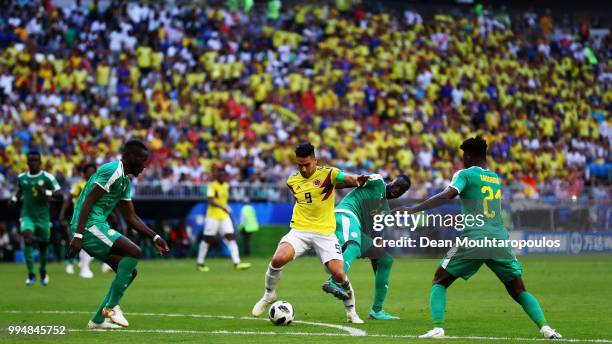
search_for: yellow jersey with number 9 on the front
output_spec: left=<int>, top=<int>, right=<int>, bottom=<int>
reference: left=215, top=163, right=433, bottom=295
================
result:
left=287, top=166, right=344, bottom=234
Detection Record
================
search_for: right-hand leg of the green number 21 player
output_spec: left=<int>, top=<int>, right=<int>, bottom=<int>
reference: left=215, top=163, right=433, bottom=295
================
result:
left=486, top=259, right=561, bottom=339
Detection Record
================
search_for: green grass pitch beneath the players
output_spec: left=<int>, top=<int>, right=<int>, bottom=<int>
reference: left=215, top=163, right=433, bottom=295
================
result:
left=0, top=255, right=612, bottom=344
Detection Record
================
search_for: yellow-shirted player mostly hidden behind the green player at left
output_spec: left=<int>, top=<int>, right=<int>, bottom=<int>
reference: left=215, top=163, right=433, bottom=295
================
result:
left=59, top=163, right=97, bottom=278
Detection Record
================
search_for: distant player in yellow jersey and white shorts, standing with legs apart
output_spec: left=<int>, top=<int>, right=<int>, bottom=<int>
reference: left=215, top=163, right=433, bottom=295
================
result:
left=196, top=165, right=251, bottom=272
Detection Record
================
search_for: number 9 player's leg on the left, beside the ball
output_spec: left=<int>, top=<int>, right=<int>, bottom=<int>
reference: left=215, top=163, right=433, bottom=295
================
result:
left=251, top=229, right=310, bottom=317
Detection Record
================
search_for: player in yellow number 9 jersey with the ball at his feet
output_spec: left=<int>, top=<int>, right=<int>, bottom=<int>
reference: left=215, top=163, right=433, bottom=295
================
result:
left=252, top=143, right=368, bottom=323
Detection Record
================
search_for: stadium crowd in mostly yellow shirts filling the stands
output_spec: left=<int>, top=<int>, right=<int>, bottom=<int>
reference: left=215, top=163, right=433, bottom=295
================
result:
left=0, top=0, right=612, bottom=198
